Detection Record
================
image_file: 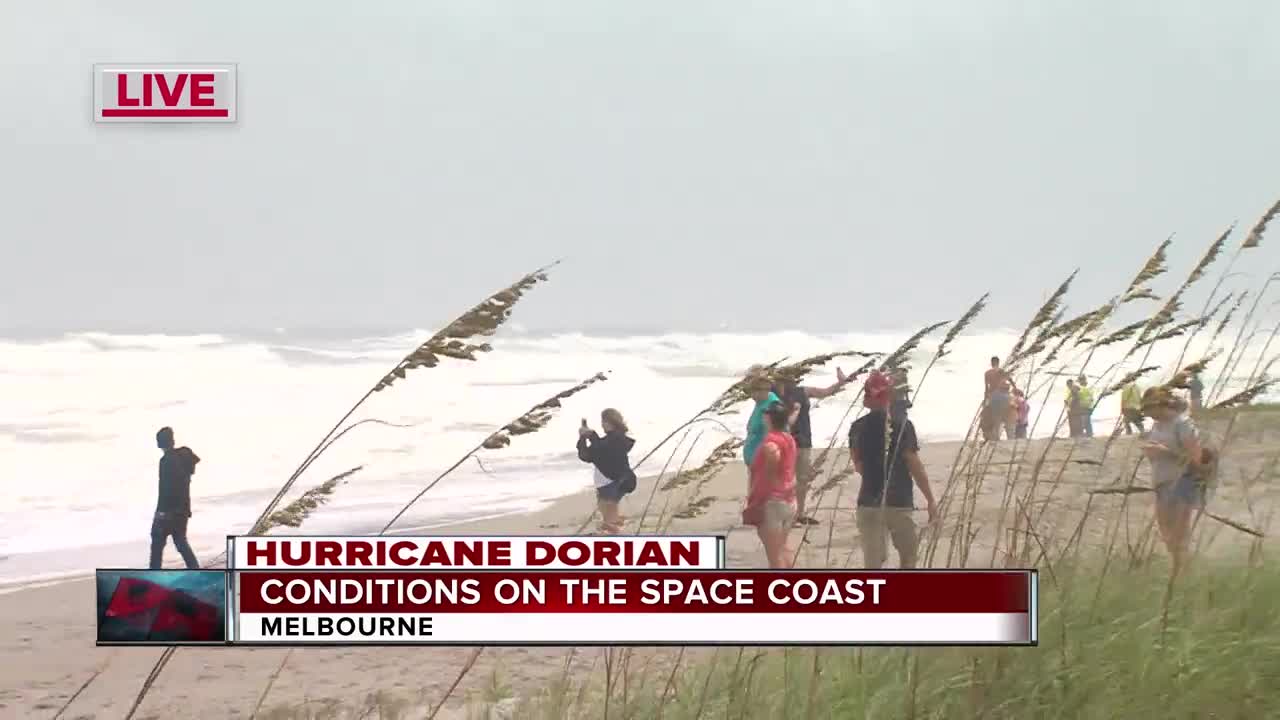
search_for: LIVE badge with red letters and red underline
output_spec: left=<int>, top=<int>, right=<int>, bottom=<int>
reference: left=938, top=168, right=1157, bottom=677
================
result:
left=93, top=64, right=236, bottom=123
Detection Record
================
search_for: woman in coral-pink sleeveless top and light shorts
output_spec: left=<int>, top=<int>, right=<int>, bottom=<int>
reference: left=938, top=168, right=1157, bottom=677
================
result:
left=742, top=402, right=797, bottom=568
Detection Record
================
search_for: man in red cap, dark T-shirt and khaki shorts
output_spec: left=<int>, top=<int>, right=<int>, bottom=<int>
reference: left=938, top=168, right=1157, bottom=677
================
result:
left=849, top=372, right=938, bottom=570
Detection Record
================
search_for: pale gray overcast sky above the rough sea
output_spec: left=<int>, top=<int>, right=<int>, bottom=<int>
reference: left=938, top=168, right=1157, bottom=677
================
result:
left=0, top=0, right=1280, bottom=332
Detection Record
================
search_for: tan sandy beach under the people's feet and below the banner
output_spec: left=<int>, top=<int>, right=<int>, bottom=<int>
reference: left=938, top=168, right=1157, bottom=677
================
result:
left=0, top=415, right=1276, bottom=720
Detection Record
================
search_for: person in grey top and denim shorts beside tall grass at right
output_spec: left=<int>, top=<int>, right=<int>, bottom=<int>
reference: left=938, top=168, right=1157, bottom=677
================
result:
left=1142, top=387, right=1211, bottom=574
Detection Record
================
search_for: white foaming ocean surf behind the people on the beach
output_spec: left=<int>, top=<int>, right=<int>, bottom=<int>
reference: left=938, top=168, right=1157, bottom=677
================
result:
left=0, top=325, right=1252, bottom=584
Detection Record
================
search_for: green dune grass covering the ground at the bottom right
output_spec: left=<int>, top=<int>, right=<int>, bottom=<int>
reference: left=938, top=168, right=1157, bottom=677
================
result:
left=471, top=562, right=1280, bottom=720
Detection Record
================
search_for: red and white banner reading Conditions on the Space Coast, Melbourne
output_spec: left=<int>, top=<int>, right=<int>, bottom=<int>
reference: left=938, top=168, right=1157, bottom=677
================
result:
left=234, top=570, right=1037, bottom=644
